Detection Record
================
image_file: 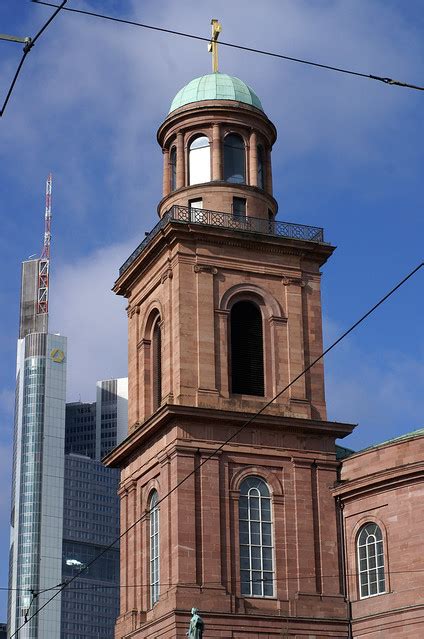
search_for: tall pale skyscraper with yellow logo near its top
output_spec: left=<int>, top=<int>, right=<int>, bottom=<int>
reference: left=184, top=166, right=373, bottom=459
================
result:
left=8, top=259, right=66, bottom=639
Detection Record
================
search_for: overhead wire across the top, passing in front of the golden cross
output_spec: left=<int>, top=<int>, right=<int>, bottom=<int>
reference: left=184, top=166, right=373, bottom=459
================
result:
left=32, top=0, right=424, bottom=91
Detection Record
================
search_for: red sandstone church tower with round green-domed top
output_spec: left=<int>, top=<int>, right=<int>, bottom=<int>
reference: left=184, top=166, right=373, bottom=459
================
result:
left=106, top=30, right=352, bottom=639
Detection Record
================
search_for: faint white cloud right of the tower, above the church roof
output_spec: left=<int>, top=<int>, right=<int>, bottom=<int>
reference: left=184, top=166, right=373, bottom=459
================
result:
left=324, top=318, right=424, bottom=448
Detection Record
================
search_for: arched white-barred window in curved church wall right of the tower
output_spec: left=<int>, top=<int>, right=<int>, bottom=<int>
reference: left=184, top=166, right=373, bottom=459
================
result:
left=357, top=522, right=386, bottom=599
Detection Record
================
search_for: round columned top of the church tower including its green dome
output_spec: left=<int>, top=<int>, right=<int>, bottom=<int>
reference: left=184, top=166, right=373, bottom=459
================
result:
left=157, top=73, right=278, bottom=221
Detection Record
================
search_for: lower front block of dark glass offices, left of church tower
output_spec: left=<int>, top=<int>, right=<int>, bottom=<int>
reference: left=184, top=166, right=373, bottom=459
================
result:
left=61, top=453, right=119, bottom=639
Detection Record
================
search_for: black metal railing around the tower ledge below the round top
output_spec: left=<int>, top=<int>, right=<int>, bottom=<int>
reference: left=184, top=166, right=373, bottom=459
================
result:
left=119, top=205, right=324, bottom=275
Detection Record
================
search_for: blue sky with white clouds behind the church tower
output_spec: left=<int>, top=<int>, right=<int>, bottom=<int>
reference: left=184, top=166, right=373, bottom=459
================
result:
left=0, top=0, right=424, bottom=620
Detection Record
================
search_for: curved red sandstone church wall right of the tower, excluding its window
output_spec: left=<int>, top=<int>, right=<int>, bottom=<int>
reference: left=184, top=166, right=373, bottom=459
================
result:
left=335, top=436, right=424, bottom=639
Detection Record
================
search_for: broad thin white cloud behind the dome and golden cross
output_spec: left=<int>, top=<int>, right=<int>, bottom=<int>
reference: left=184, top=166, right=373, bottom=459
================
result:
left=0, top=0, right=422, bottom=228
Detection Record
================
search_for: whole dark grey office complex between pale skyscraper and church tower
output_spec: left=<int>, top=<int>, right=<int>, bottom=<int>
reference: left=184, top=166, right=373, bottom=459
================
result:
left=60, top=378, right=128, bottom=639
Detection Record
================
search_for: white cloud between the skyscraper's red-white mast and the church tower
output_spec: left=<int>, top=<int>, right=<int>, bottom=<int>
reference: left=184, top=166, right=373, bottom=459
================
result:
left=50, top=244, right=135, bottom=401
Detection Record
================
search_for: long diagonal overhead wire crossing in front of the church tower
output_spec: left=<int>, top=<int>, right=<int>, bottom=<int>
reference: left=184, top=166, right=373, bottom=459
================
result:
left=10, top=262, right=424, bottom=639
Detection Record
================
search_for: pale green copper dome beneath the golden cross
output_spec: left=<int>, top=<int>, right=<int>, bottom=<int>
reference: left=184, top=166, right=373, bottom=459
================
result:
left=169, top=73, right=263, bottom=113
